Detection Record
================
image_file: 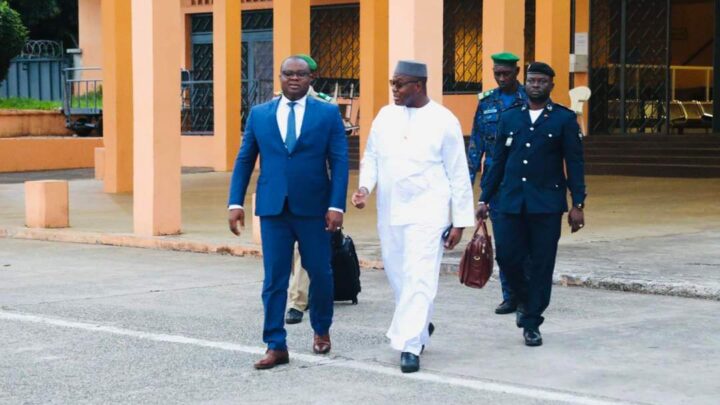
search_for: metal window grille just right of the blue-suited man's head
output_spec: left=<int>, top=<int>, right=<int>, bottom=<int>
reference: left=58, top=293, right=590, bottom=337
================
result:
left=310, top=4, right=360, bottom=97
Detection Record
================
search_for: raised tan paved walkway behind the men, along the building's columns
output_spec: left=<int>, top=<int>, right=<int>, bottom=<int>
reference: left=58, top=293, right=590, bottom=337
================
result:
left=0, top=169, right=720, bottom=300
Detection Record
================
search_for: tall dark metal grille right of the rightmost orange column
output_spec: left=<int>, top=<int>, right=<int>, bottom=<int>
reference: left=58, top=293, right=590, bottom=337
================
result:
left=589, top=0, right=672, bottom=134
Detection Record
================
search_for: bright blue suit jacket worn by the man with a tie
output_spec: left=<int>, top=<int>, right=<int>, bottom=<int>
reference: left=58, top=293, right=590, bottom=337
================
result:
left=228, top=97, right=348, bottom=216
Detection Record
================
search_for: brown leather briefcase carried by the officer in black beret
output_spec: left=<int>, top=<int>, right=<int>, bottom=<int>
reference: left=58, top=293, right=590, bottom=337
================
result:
left=459, top=219, right=493, bottom=288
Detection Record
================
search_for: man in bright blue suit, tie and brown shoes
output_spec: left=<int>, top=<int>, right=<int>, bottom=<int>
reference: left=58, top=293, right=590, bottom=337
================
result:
left=228, top=56, right=348, bottom=369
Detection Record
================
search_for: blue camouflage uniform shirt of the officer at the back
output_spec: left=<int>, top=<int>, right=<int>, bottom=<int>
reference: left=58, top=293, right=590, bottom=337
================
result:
left=468, top=83, right=527, bottom=188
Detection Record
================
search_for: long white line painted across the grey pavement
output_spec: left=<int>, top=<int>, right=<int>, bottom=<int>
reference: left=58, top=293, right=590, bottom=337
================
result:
left=0, top=311, right=632, bottom=405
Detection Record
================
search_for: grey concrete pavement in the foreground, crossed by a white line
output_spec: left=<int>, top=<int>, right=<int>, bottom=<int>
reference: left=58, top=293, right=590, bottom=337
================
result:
left=0, top=239, right=720, bottom=404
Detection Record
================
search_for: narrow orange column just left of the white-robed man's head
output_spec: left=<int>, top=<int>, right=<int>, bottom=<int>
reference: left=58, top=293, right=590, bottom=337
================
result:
left=360, top=0, right=390, bottom=159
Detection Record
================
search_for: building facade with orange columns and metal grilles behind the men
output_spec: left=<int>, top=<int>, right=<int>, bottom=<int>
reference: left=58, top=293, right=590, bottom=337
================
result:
left=73, top=0, right=718, bottom=234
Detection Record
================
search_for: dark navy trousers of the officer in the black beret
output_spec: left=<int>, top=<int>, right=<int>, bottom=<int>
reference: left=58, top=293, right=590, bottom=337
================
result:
left=493, top=212, right=563, bottom=328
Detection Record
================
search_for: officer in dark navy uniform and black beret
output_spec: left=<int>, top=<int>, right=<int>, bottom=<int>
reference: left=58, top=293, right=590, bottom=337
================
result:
left=477, top=62, right=586, bottom=346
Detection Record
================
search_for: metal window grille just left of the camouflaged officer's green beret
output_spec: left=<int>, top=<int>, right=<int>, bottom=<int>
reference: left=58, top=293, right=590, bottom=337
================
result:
left=443, top=0, right=483, bottom=94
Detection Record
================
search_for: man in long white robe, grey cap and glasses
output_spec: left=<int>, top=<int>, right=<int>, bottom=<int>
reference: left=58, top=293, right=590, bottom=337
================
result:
left=352, top=61, right=475, bottom=372
